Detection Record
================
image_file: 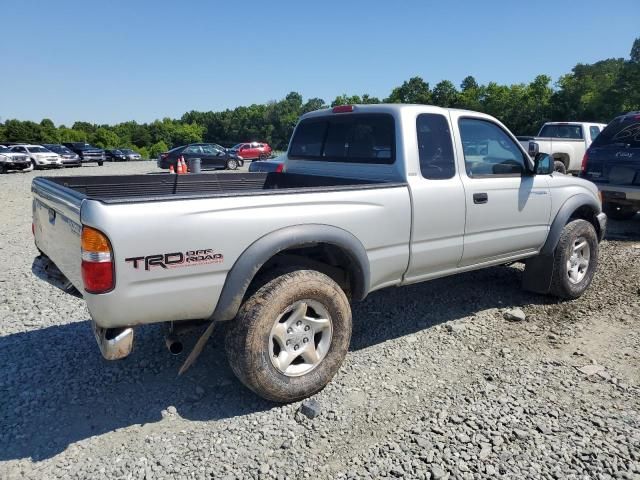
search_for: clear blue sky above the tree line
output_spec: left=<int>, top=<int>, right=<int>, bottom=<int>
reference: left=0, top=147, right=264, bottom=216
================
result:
left=0, top=0, right=640, bottom=124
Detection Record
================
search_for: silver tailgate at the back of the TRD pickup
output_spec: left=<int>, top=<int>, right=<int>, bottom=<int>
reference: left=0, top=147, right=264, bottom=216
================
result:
left=31, top=178, right=84, bottom=292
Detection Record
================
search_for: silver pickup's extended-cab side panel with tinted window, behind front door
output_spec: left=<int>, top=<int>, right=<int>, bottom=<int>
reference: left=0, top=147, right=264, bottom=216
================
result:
left=405, top=113, right=465, bottom=283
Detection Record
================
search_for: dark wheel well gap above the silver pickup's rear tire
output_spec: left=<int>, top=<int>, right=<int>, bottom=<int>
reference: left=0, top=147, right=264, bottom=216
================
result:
left=245, top=243, right=364, bottom=299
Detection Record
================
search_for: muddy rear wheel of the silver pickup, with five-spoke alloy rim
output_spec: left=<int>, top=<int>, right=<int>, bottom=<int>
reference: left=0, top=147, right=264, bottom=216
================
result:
left=225, top=270, right=351, bottom=402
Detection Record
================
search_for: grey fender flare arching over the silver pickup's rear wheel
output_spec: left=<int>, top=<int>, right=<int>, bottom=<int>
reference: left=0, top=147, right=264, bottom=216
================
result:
left=211, top=224, right=370, bottom=321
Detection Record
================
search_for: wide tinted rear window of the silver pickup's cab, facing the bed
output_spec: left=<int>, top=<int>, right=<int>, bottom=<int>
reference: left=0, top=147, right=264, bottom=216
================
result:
left=289, top=114, right=395, bottom=164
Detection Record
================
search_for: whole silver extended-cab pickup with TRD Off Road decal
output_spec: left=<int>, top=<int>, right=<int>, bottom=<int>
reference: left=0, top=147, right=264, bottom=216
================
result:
left=32, top=105, right=606, bottom=402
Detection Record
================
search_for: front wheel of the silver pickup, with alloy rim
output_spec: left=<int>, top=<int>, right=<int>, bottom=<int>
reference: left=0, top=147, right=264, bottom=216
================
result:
left=551, top=220, right=598, bottom=299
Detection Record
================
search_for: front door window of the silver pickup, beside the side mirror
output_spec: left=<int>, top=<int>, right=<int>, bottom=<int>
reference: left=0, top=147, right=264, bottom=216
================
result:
left=458, top=118, right=526, bottom=177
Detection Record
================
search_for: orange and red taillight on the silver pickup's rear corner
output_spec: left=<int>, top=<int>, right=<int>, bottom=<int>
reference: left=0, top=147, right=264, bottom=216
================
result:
left=81, top=226, right=115, bottom=293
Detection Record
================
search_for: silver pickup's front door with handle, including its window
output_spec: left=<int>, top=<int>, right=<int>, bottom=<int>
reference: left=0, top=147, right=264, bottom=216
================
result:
left=455, top=113, right=551, bottom=267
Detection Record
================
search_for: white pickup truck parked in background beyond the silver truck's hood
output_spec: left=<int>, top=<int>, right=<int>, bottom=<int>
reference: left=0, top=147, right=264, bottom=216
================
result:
left=518, top=122, right=607, bottom=173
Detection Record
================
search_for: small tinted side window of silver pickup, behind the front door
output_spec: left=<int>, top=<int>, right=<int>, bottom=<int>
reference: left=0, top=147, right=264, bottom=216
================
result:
left=416, top=113, right=456, bottom=180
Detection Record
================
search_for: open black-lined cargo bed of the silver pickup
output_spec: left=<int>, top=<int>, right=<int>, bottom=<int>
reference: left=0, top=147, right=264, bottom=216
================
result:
left=34, top=173, right=402, bottom=204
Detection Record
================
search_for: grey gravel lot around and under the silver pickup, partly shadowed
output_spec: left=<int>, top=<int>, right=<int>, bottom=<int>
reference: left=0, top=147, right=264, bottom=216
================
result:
left=0, top=162, right=640, bottom=479
